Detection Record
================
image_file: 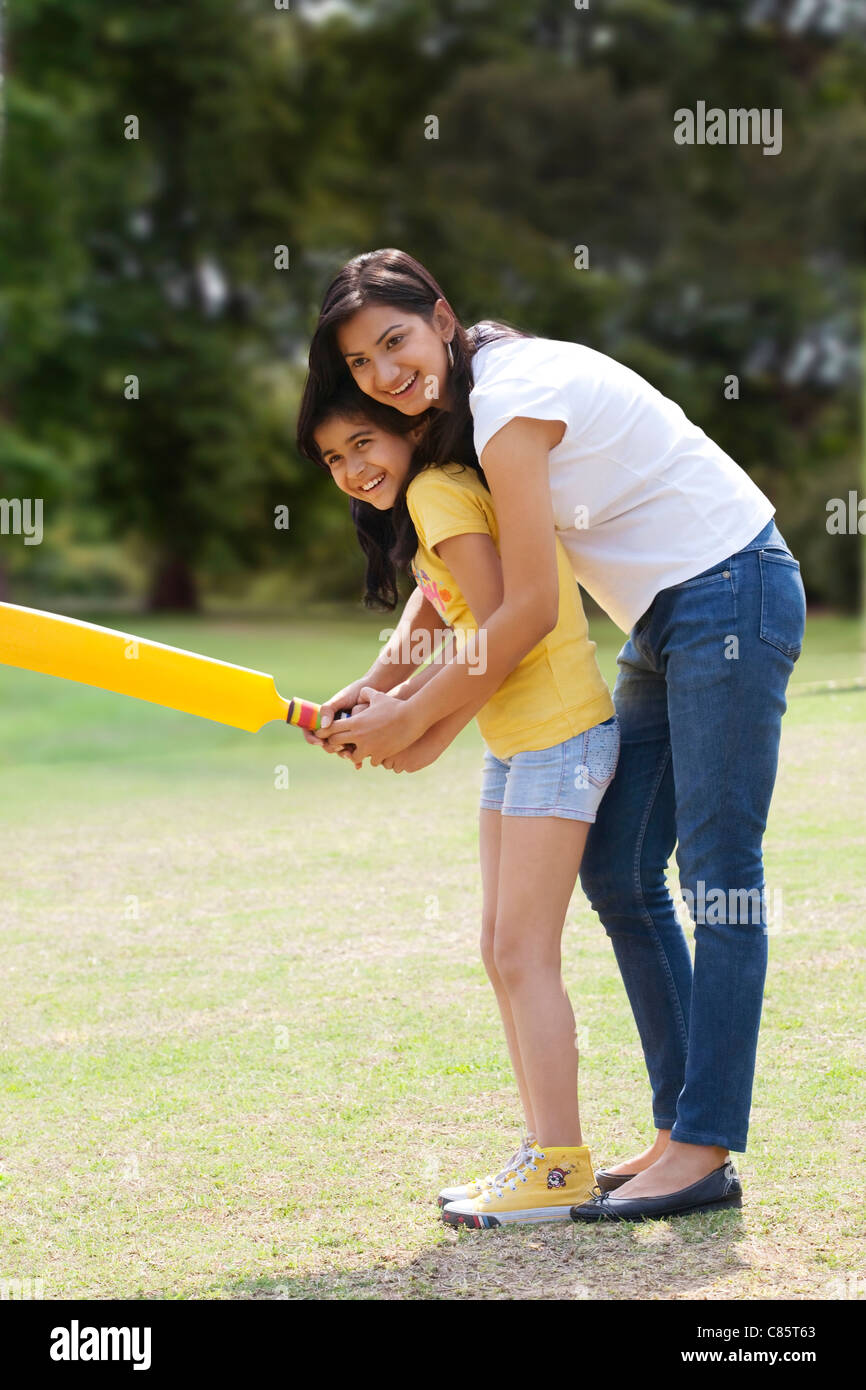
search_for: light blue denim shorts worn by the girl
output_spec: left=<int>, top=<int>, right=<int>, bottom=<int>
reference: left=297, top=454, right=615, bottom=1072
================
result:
left=481, top=714, right=620, bottom=823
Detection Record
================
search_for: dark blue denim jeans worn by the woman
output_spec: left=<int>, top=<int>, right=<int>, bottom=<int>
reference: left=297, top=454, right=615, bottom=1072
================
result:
left=581, top=521, right=806, bottom=1152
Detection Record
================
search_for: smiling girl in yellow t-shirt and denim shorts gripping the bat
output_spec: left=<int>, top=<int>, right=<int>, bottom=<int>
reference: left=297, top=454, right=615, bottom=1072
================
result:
left=300, top=386, right=619, bottom=1227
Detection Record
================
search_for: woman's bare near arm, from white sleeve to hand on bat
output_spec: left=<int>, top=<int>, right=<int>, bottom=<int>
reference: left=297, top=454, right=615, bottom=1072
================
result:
left=325, top=418, right=566, bottom=765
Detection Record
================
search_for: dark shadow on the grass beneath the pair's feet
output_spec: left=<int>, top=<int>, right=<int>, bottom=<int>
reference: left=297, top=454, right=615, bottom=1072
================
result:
left=225, top=1211, right=748, bottom=1301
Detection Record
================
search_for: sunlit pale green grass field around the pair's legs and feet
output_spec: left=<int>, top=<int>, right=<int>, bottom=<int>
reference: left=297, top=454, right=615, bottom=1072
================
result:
left=0, top=614, right=866, bottom=1300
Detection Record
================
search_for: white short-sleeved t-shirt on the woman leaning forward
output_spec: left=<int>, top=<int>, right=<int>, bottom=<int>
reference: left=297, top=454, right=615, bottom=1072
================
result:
left=468, top=338, right=776, bottom=632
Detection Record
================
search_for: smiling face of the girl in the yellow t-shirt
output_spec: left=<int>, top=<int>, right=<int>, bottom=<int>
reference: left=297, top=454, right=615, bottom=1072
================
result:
left=316, top=416, right=413, bottom=512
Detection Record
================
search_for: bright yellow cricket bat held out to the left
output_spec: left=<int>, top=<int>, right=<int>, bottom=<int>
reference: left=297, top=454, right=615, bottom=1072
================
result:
left=0, top=603, right=343, bottom=734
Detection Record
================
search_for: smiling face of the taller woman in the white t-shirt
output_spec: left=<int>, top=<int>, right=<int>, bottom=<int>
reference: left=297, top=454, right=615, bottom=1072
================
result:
left=336, top=300, right=455, bottom=416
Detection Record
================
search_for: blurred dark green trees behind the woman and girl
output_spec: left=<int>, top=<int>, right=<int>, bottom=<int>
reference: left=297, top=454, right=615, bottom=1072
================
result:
left=0, top=0, right=866, bottom=609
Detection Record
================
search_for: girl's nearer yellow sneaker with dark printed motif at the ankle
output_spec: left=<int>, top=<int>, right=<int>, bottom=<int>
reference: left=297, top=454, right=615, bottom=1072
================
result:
left=442, top=1144, right=595, bottom=1229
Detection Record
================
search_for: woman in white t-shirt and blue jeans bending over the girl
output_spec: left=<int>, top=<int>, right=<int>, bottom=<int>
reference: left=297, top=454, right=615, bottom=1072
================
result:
left=300, top=250, right=805, bottom=1220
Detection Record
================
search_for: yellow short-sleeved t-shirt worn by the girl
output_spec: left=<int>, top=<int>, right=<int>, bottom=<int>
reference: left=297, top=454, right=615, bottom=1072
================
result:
left=406, top=463, right=614, bottom=758
